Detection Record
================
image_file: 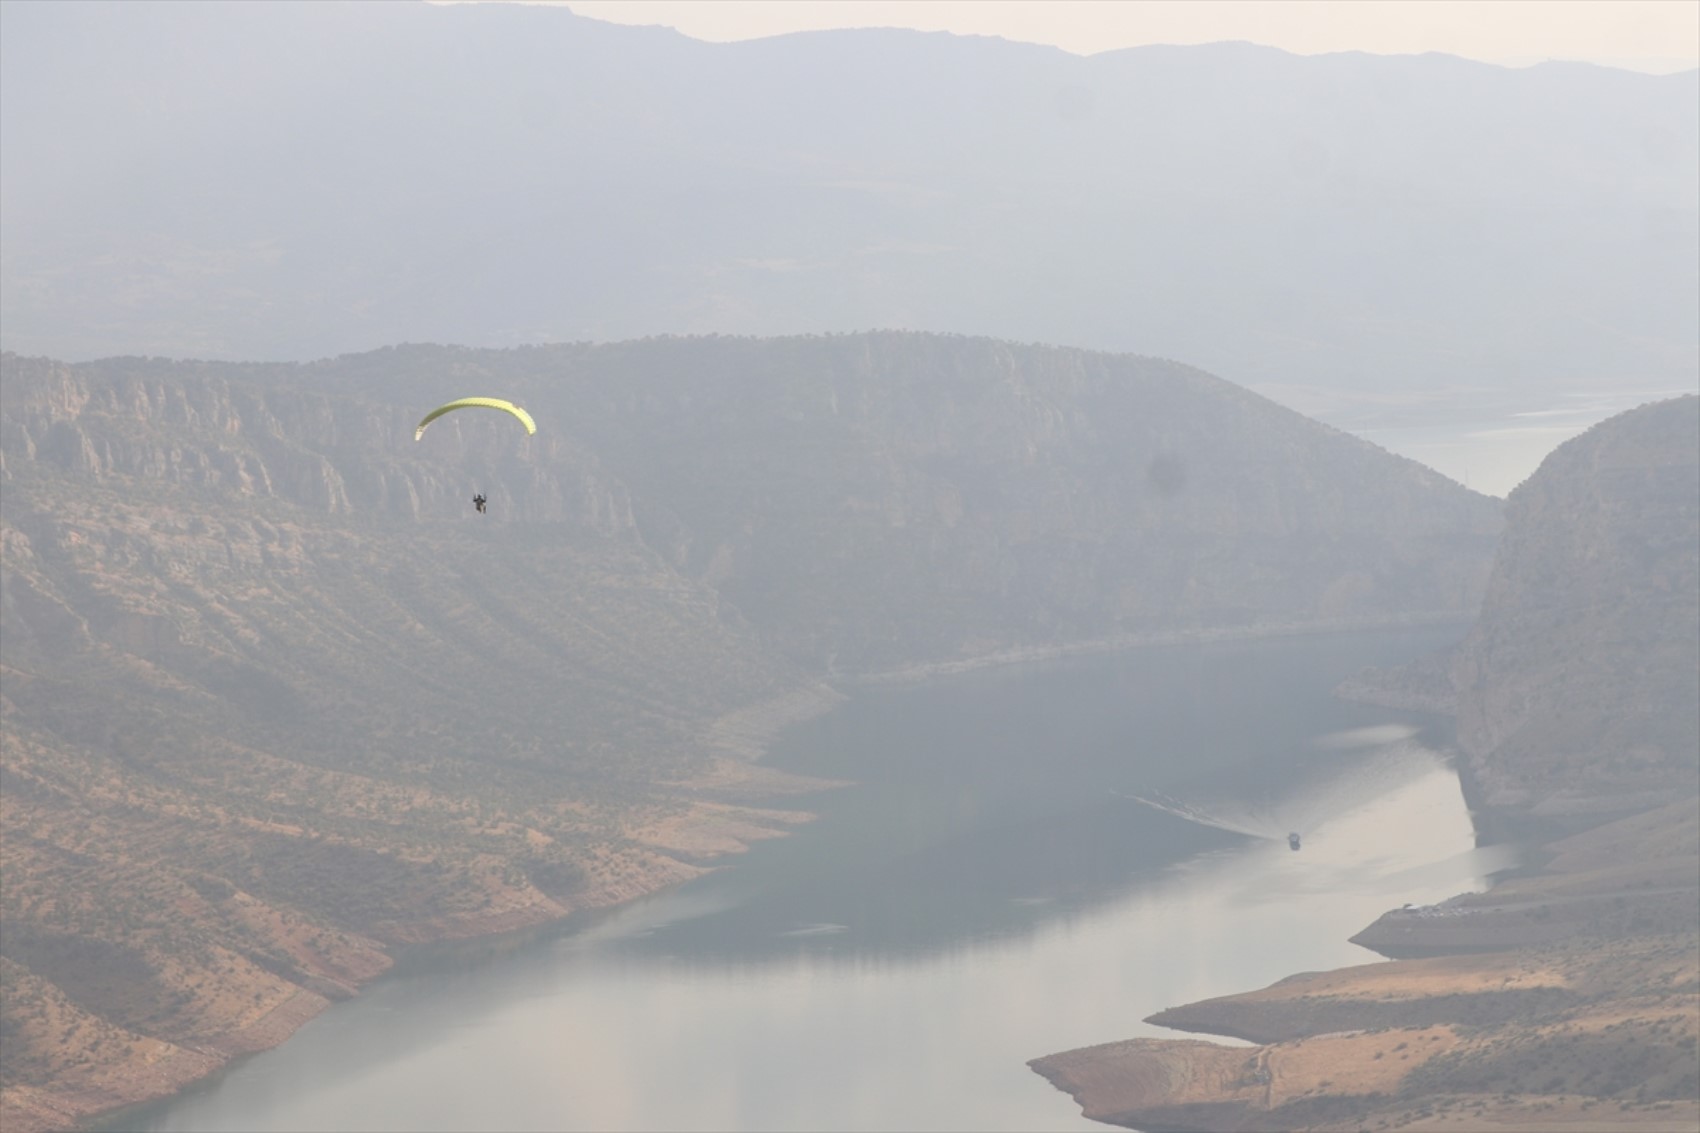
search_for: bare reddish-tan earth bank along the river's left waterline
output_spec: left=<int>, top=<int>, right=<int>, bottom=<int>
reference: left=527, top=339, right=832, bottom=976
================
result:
left=0, top=686, right=843, bottom=1133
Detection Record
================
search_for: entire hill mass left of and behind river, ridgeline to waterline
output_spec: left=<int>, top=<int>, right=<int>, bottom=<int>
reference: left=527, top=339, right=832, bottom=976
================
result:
left=0, top=333, right=1499, bottom=1130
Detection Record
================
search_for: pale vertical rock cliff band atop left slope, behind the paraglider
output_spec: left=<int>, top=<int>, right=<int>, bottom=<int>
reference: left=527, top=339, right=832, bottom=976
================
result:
left=0, top=359, right=631, bottom=532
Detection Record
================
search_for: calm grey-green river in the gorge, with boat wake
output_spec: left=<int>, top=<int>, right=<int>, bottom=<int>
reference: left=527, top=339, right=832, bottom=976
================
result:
left=121, top=629, right=1493, bottom=1131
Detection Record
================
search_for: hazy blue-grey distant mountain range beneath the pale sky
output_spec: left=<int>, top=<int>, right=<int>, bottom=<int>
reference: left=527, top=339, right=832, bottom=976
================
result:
left=0, top=2, right=1700, bottom=438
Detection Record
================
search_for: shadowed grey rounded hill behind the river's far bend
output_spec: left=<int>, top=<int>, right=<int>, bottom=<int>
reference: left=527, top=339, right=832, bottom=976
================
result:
left=294, top=333, right=1498, bottom=672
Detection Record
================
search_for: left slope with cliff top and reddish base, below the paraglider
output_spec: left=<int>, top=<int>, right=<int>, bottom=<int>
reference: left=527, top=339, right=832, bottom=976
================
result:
left=0, top=350, right=819, bottom=1130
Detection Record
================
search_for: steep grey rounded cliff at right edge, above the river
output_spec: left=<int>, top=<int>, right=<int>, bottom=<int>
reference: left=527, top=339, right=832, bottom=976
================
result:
left=1452, top=396, right=1700, bottom=818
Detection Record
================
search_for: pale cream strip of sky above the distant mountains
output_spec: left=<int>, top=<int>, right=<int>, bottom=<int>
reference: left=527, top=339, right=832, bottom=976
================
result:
left=568, top=0, right=1700, bottom=71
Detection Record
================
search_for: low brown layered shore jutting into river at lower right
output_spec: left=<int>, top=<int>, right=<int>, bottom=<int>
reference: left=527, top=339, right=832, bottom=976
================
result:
left=1027, top=798, right=1700, bottom=1133
